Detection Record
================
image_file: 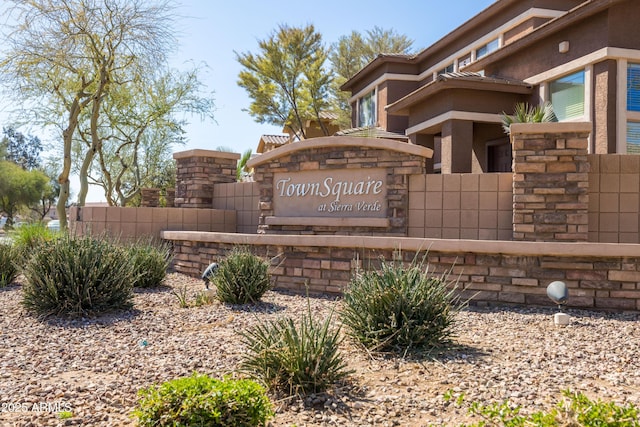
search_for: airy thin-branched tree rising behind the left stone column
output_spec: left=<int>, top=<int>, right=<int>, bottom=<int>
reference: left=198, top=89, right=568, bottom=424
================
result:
left=75, top=69, right=214, bottom=206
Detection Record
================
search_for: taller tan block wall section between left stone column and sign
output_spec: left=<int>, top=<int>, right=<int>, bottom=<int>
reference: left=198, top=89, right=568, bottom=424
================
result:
left=213, top=182, right=260, bottom=234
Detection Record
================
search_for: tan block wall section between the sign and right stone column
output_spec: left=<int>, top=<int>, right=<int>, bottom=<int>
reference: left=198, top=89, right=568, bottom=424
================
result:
left=408, top=173, right=513, bottom=240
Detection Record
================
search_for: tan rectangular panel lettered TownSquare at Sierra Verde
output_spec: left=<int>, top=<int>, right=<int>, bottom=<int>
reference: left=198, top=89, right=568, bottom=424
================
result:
left=273, top=168, right=387, bottom=218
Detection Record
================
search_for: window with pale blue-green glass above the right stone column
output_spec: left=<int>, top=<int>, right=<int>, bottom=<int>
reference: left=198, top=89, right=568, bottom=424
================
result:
left=549, top=71, right=584, bottom=122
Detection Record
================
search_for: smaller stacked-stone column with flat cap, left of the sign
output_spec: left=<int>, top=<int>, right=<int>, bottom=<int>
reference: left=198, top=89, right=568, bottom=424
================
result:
left=173, top=150, right=240, bottom=208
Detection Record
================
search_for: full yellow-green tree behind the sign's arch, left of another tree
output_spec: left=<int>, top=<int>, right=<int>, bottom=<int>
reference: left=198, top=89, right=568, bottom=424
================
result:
left=236, top=25, right=333, bottom=139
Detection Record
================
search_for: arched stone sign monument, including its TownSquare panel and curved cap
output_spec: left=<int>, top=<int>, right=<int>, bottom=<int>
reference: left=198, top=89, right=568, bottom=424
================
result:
left=247, top=136, right=433, bottom=236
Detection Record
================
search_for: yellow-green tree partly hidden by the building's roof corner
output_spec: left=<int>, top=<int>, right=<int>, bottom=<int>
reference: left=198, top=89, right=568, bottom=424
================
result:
left=329, top=26, right=413, bottom=128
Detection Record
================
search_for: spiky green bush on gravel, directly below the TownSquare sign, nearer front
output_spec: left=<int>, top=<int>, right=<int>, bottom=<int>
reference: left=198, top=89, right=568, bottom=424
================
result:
left=241, top=309, right=349, bottom=395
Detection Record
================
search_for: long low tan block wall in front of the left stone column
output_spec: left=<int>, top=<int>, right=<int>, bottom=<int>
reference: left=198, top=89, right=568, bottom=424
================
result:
left=69, top=206, right=236, bottom=239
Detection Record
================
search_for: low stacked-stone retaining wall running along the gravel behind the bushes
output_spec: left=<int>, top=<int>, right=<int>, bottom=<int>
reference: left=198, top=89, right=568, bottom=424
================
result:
left=171, top=236, right=640, bottom=311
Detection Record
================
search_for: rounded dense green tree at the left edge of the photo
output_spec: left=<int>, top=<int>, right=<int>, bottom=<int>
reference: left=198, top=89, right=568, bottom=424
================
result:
left=0, top=160, right=49, bottom=226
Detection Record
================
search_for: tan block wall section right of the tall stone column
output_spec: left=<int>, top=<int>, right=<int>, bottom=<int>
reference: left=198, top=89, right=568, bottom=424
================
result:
left=589, top=154, right=640, bottom=243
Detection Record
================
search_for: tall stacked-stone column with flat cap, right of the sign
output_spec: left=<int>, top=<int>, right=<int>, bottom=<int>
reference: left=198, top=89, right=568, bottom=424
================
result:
left=511, top=123, right=591, bottom=242
